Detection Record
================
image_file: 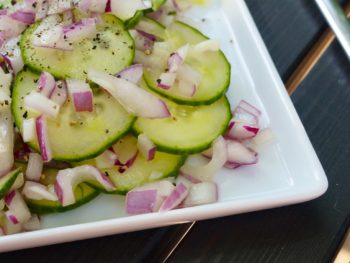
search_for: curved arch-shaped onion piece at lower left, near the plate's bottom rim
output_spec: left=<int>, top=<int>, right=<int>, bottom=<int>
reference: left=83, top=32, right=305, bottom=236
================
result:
left=55, top=165, right=115, bottom=206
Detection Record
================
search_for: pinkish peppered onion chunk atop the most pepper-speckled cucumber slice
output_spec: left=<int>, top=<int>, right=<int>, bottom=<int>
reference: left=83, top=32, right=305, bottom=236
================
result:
left=63, top=18, right=97, bottom=43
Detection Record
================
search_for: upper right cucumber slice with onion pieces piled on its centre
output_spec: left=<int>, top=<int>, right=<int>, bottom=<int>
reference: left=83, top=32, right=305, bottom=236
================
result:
left=140, top=21, right=231, bottom=105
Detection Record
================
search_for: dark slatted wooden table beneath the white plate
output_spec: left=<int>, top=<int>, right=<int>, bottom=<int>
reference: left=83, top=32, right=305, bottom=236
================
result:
left=0, top=0, right=350, bottom=263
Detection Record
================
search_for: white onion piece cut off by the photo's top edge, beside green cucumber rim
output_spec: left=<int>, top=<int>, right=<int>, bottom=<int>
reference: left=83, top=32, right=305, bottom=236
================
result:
left=111, top=0, right=152, bottom=20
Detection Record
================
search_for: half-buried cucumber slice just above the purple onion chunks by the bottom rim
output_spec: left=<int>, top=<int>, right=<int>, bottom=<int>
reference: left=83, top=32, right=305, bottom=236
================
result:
left=82, top=135, right=186, bottom=194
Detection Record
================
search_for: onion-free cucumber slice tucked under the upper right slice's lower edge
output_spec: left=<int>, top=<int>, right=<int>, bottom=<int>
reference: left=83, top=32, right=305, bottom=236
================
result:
left=133, top=92, right=232, bottom=154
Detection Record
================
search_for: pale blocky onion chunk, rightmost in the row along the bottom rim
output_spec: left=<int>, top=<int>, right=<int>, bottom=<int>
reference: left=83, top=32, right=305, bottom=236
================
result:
left=183, top=182, right=218, bottom=207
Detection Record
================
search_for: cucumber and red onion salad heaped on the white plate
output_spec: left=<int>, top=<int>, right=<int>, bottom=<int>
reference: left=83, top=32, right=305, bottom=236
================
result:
left=0, top=0, right=272, bottom=235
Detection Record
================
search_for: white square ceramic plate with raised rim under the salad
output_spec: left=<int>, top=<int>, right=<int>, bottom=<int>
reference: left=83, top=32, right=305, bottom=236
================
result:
left=0, top=0, right=328, bottom=252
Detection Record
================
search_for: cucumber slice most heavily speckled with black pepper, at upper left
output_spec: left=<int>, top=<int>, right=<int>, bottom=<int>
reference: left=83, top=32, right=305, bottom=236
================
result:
left=21, top=14, right=134, bottom=79
